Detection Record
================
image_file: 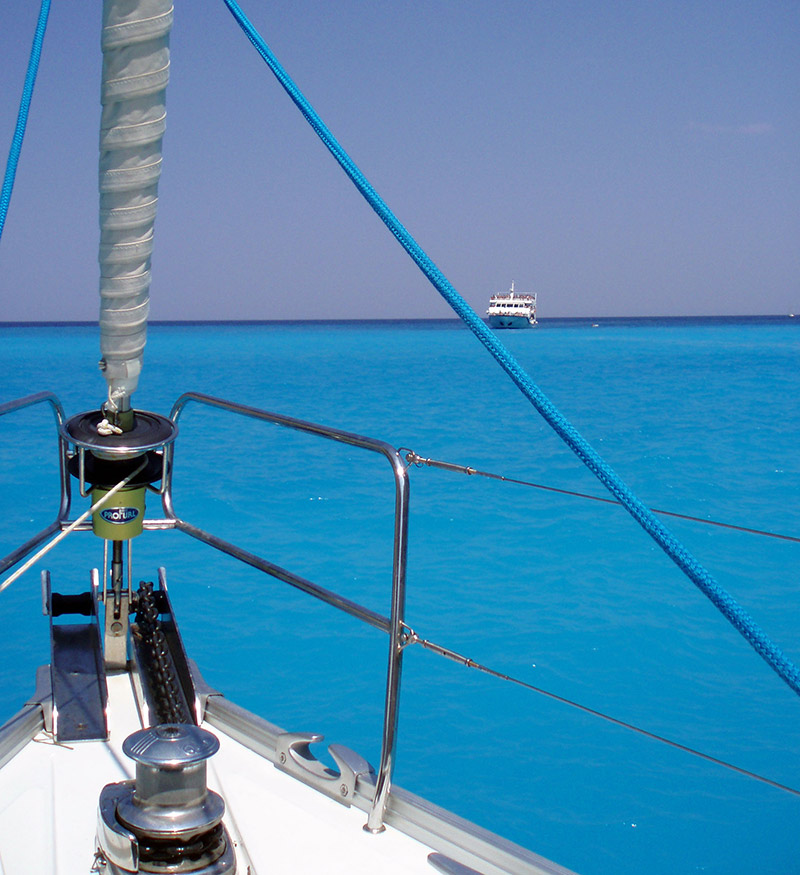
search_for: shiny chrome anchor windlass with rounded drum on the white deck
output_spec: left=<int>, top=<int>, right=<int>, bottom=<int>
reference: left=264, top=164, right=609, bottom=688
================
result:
left=97, top=723, right=236, bottom=875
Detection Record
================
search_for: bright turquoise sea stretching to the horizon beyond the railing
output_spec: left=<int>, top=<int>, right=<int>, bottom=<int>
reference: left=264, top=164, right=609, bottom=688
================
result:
left=0, top=317, right=800, bottom=875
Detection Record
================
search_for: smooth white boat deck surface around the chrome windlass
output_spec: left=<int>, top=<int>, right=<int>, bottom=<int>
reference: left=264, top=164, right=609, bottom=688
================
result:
left=0, top=675, right=435, bottom=875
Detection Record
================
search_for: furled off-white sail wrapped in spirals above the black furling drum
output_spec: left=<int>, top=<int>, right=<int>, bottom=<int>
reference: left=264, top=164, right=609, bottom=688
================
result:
left=100, top=0, right=172, bottom=416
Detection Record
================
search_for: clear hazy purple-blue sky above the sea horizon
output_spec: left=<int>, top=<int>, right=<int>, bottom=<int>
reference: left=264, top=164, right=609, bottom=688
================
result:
left=0, top=0, right=800, bottom=320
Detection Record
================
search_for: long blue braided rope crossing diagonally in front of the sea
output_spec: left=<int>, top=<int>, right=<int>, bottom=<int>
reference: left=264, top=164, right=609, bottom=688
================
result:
left=224, top=0, right=800, bottom=695
